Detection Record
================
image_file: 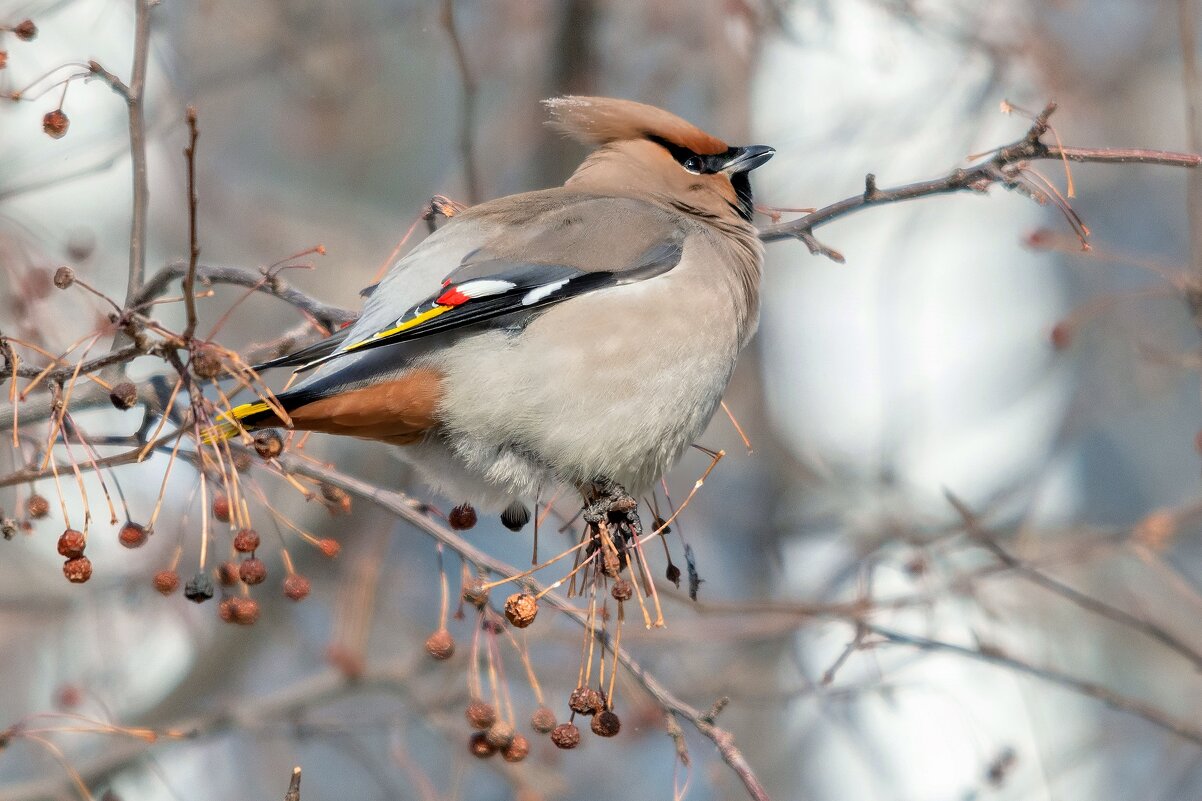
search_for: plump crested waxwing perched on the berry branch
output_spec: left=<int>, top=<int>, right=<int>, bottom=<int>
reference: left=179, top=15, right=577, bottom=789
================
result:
left=215, top=96, right=775, bottom=530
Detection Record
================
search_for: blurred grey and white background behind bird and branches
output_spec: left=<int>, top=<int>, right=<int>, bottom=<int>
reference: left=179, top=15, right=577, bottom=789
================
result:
left=0, top=0, right=1202, bottom=801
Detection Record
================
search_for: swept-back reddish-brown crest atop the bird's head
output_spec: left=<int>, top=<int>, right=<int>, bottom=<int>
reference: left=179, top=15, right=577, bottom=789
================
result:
left=543, top=95, right=728, bottom=155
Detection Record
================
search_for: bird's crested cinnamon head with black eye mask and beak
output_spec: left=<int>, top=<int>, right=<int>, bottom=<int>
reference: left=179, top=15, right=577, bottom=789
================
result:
left=546, top=96, right=775, bottom=221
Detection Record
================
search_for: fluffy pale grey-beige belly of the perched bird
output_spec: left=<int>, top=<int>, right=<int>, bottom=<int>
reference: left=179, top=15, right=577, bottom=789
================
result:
left=439, top=280, right=739, bottom=494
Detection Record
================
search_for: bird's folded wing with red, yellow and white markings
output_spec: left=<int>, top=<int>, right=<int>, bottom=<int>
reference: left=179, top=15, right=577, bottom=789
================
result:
left=290, top=190, right=686, bottom=370
